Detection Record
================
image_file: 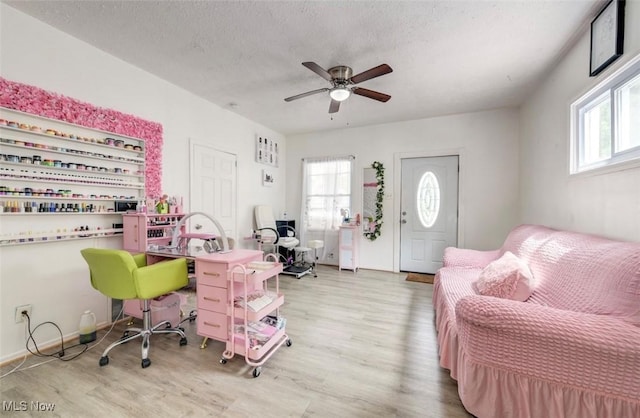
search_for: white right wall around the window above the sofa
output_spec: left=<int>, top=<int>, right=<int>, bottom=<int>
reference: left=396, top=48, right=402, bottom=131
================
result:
left=520, top=1, right=640, bottom=241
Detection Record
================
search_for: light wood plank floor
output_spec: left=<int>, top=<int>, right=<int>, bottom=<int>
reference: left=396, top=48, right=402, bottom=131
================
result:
left=0, top=266, right=471, bottom=418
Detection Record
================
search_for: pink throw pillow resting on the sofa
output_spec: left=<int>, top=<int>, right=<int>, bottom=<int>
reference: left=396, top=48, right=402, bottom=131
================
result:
left=473, top=251, right=534, bottom=302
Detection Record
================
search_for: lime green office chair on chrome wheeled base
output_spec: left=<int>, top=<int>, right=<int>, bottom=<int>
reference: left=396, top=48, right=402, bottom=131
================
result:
left=80, top=248, right=189, bottom=368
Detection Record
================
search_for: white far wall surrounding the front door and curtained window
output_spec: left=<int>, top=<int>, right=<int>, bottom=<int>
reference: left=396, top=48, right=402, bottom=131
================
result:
left=287, top=109, right=518, bottom=271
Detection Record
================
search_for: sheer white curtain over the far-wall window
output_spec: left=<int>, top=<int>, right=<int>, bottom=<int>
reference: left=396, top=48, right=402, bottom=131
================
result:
left=298, top=156, right=354, bottom=264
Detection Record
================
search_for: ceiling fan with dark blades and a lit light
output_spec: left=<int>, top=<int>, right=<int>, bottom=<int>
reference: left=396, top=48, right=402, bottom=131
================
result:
left=284, top=62, right=393, bottom=113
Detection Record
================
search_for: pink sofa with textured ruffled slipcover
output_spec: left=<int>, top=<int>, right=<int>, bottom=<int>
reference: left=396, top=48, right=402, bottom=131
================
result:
left=433, top=225, right=640, bottom=418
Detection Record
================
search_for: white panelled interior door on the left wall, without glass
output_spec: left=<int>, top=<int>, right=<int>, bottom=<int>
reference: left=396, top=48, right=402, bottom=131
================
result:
left=190, top=142, right=237, bottom=242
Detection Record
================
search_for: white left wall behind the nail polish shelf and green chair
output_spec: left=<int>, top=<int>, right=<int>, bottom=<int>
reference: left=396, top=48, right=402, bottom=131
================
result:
left=0, top=4, right=286, bottom=361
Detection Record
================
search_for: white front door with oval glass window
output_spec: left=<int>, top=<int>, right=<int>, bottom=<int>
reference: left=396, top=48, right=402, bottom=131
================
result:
left=400, top=155, right=458, bottom=274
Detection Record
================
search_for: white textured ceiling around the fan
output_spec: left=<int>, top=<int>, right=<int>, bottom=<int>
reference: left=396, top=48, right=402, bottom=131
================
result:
left=3, top=0, right=602, bottom=135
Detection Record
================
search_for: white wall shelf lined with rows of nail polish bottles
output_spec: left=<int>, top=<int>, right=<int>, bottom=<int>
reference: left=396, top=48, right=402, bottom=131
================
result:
left=0, top=108, right=145, bottom=246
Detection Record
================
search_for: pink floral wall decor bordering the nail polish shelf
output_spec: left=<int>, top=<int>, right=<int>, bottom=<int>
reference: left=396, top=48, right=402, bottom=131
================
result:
left=0, top=77, right=162, bottom=197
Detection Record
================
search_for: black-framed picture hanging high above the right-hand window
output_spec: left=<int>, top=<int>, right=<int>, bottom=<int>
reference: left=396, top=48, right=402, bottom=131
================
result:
left=589, top=0, right=624, bottom=77
